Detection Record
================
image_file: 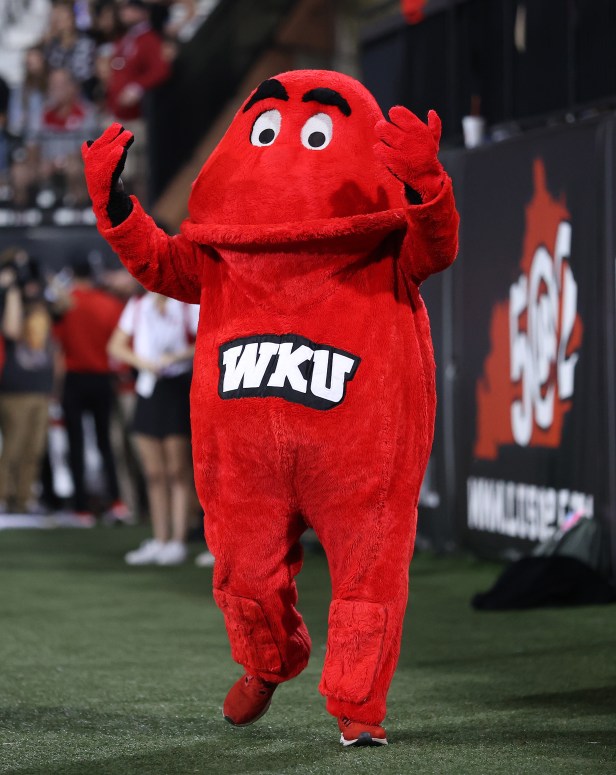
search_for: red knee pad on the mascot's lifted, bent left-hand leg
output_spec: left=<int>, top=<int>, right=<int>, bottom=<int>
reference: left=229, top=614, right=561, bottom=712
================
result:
left=214, top=589, right=282, bottom=673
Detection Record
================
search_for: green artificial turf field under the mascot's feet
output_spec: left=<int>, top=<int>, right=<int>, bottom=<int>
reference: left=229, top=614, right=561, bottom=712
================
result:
left=0, top=528, right=616, bottom=775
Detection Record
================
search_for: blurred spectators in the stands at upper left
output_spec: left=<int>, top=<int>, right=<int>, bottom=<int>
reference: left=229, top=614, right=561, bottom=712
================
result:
left=0, top=0, right=212, bottom=209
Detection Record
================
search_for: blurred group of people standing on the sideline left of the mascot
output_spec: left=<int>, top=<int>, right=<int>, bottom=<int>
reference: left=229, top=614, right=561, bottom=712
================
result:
left=0, top=247, right=213, bottom=565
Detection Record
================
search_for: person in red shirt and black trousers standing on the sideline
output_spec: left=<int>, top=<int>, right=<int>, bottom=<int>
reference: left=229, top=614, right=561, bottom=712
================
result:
left=54, top=261, right=132, bottom=521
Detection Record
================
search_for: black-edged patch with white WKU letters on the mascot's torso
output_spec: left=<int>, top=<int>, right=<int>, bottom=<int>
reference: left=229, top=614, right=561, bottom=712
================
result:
left=218, top=334, right=361, bottom=416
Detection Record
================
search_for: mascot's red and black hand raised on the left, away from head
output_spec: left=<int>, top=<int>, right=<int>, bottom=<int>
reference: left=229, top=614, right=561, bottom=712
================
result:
left=81, top=123, right=134, bottom=228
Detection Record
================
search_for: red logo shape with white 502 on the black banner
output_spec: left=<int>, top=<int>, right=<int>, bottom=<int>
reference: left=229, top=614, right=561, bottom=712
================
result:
left=475, top=160, right=583, bottom=460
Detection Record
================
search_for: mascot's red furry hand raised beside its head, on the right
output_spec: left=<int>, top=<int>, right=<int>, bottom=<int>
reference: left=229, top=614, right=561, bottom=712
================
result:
left=374, top=105, right=445, bottom=204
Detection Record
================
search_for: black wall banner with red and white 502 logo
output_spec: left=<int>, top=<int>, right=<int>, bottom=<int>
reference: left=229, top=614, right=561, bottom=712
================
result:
left=450, top=118, right=616, bottom=556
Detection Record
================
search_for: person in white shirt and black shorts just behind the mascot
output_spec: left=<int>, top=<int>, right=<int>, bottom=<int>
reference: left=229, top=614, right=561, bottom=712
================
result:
left=107, top=293, right=199, bottom=565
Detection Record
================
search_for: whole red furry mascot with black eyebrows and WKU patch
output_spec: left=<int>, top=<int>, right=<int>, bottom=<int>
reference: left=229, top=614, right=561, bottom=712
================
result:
left=83, top=71, right=458, bottom=745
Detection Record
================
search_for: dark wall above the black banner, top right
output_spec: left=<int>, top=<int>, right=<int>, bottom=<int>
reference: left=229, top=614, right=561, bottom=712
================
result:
left=362, top=0, right=616, bottom=142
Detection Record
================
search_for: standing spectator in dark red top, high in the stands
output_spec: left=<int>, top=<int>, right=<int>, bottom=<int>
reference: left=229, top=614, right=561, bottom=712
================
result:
left=107, top=0, right=169, bottom=198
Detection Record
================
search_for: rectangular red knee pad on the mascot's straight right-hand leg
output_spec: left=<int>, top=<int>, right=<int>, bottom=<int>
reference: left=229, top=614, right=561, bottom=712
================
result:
left=319, top=600, right=387, bottom=703
